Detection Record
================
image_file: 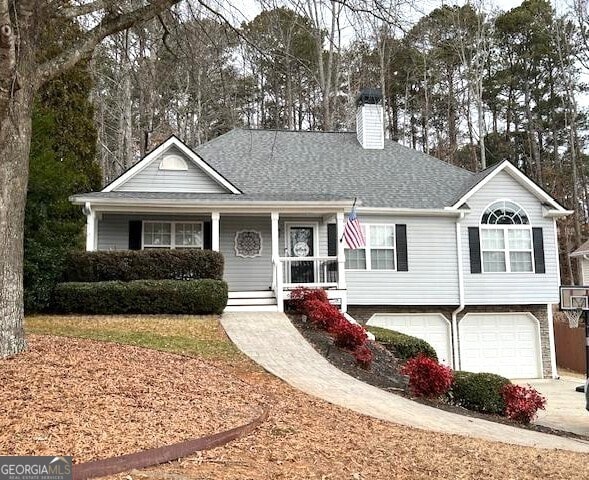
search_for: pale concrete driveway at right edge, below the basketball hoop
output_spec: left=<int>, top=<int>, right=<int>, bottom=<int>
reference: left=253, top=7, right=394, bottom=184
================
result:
left=524, top=377, right=589, bottom=436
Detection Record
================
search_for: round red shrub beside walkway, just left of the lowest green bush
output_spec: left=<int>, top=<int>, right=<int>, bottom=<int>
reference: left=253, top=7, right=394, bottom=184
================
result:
left=401, top=354, right=454, bottom=397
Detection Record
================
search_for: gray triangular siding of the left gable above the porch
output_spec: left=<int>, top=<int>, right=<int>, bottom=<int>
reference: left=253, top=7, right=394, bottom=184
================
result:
left=114, top=148, right=227, bottom=193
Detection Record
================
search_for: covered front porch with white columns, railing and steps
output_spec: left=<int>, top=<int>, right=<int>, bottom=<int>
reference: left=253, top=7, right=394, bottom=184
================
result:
left=84, top=205, right=347, bottom=312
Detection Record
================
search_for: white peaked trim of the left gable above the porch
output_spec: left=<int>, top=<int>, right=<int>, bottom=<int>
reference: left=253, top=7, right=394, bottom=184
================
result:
left=102, top=135, right=242, bottom=195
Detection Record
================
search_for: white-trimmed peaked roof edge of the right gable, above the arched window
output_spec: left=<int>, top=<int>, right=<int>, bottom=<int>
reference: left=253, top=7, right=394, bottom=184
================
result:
left=450, top=160, right=570, bottom=215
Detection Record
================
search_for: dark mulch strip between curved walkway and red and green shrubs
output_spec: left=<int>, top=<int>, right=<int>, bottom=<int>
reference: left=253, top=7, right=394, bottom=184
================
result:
left=289, top=314, right=589, bottom=440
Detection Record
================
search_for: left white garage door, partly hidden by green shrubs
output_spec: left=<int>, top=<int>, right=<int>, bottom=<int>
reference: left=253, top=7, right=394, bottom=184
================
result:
left=366, top=313, right=452, bottom=366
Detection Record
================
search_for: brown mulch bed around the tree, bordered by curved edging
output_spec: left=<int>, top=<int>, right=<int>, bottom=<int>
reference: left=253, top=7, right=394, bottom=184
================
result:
left=0, top=335, right=267, bottom=463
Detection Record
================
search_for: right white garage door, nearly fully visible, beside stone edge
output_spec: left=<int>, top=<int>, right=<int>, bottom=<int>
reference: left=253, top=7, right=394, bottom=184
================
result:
left=458, top=313, right=542, bottom=378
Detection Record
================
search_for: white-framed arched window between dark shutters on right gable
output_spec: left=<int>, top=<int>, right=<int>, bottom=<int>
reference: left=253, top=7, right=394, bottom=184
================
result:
left=480, top=200, right=534, bottom=272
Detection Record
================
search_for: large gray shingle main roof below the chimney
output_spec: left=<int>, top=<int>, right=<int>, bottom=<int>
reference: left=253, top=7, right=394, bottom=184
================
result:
left=195, top=129, right=480, bottom=208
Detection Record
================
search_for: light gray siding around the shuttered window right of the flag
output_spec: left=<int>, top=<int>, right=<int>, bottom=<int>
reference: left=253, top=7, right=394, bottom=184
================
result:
left=346, top=215, right=458, bottom=305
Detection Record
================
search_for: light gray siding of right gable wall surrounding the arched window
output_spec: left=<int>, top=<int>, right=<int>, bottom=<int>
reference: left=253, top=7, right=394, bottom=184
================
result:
left=462, top=172, right=559, bottom=305
